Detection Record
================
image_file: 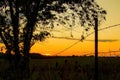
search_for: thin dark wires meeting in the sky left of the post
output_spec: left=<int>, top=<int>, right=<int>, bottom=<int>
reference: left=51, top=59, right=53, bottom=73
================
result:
left=52, top=24, right=120, bottom=55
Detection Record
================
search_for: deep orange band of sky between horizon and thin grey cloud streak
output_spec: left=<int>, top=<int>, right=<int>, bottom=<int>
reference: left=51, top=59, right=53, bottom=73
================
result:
left=31, top=38, right=120, bottom=56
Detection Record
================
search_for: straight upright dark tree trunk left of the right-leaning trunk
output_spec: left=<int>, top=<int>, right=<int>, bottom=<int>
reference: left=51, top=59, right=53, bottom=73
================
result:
left=8, top=0, right=21, bottom=80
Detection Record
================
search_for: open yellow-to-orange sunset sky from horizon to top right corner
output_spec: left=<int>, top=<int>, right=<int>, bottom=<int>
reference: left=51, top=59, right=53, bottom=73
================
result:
left=31, top=0, right=120, bottom=56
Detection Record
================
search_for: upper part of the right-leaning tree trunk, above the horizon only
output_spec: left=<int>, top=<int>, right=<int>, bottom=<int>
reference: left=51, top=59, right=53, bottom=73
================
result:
left=23, top=0, right=42, bottom=56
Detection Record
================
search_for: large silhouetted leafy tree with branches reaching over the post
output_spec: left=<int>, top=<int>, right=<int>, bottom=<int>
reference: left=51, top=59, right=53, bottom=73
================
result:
left=0, top=0, right=106, bottom=79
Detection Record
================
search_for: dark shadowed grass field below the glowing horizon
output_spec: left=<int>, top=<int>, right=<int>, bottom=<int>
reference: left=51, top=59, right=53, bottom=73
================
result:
left=0, top=56, right=120, bottom=80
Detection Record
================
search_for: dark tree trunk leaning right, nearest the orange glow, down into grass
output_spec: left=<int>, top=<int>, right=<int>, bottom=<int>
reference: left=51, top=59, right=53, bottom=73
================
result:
left=23, top=0, right=40, bottom=77
